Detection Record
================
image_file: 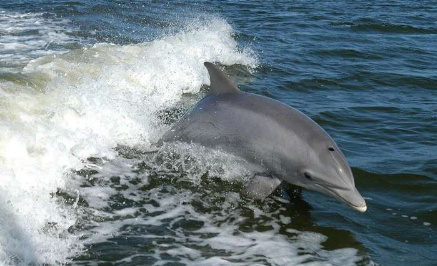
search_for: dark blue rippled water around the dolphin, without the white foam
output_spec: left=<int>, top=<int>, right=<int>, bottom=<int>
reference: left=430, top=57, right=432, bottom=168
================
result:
left=0, top=0, right=437, bottom=266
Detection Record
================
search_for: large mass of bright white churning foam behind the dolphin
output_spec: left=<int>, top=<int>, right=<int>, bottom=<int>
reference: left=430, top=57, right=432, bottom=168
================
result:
left=0, top=16, right=257, bottom=265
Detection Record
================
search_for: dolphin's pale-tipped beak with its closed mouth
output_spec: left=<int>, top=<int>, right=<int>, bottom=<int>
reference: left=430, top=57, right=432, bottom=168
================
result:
left=315, top=184, right=367, bottom=212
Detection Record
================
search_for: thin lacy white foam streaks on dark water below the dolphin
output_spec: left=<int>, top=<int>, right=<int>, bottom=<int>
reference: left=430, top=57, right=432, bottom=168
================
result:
left=70, top=165, right=363, bottom=266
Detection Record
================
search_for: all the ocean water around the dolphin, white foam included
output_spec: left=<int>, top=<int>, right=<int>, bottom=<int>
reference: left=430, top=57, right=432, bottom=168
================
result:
left=0, top=0, right=437, bottom=266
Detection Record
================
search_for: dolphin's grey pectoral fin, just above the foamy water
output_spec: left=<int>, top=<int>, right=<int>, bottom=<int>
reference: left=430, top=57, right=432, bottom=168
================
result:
left=243, top=175, right=282, bottom=200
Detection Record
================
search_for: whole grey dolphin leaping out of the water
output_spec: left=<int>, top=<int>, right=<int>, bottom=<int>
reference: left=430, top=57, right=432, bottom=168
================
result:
left=160, top=62, right=367, bottom=212
